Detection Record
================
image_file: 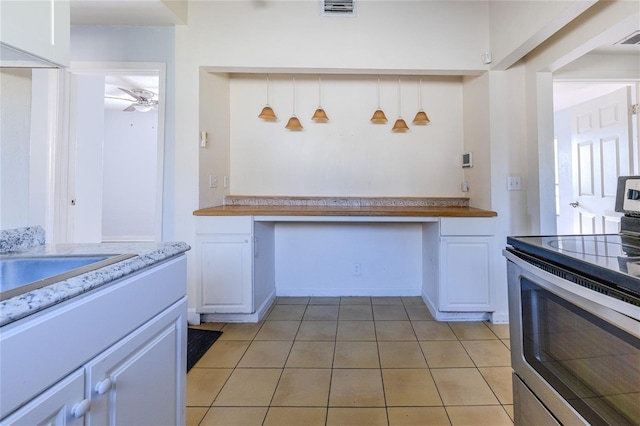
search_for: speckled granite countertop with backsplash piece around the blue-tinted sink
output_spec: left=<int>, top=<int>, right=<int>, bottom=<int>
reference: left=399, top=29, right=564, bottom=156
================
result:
left=0, top=227, right=190, bottom=326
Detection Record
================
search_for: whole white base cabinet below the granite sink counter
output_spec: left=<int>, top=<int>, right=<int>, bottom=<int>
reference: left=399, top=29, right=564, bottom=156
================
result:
left=0, top=256, right=187, bottom=425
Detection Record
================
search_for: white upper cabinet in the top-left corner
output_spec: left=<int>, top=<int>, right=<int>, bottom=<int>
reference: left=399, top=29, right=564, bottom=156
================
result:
left=0, top=0, right=71, bottom=67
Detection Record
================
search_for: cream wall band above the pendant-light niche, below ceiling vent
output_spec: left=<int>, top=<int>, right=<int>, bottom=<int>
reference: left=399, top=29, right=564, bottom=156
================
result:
left=186, top=0, right=489, bottom=74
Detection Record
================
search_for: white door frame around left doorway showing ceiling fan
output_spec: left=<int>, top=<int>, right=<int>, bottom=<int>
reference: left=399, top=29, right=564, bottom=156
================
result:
left=55, top=61, right=167, bottom=242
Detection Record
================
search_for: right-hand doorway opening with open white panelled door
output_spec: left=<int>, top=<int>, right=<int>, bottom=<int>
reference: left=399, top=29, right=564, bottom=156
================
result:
left=554, top=83, right=638, bottom=234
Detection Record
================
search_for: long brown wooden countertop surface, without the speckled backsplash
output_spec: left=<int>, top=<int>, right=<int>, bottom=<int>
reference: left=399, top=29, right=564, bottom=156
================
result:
left=193, top=205, right=498, bottom=217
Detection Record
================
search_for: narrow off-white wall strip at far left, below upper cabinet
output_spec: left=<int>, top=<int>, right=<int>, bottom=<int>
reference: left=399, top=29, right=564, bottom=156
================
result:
left=0, top=68, right=31, bottom=229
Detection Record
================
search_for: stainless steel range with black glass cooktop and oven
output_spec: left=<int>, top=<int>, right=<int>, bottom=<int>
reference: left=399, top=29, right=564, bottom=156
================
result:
left=504, top=177, right=640, bottom=425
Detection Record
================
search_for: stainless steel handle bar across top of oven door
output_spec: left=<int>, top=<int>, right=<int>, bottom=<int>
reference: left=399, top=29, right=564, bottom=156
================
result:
left=503, top=250, right=640, bottom=337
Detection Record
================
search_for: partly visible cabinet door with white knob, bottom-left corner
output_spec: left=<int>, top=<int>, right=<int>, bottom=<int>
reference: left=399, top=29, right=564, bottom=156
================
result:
left=0, top=368, right=86, bottom=426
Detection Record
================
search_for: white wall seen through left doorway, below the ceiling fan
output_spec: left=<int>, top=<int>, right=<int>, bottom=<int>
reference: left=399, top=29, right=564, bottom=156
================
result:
left=102, top=110, right=158, bottom=241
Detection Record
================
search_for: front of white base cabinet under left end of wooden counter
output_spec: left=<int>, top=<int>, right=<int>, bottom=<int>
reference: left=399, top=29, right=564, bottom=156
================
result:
left=196, top=216, right=254, bottom=314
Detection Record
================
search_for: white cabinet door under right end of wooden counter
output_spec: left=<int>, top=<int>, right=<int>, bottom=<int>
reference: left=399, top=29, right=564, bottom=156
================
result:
left=439, top=237, right=493, bottom=312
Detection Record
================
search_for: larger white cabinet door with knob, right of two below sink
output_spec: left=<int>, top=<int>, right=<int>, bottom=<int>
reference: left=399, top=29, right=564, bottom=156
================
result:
left=86, top=298, right=187, bottom=426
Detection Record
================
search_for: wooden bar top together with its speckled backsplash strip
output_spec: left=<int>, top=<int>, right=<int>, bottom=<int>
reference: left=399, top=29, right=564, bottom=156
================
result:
left=193, top=195, right=497, bottom=217
